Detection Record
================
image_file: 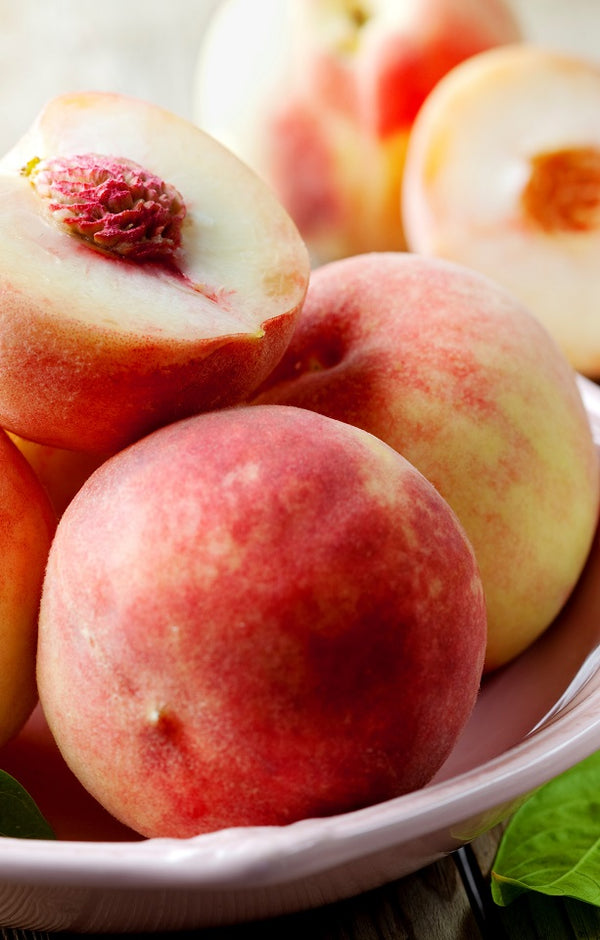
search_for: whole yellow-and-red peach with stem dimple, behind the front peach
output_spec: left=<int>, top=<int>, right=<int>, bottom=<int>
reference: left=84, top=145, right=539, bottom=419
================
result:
left=255, top=253, right=599, bottom=671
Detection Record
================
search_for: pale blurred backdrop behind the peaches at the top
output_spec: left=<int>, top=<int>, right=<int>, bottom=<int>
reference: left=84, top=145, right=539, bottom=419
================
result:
left=0, top=0, right=600, bottom=153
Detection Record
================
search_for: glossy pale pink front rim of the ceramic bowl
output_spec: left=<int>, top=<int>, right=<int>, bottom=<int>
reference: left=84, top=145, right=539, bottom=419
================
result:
left=0, top=669, right=600, bottom=890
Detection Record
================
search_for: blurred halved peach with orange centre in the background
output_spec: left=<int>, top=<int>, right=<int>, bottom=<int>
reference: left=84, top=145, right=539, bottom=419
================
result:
left=403, top=44, right=600, bottom=378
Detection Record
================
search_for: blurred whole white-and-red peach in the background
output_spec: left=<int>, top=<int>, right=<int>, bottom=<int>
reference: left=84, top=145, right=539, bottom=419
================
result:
left=194, top=0, right=521, bottom=263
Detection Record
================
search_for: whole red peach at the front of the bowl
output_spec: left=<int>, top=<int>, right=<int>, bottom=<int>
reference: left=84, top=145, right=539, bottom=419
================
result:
left=38, top=406, right=486, bottom=837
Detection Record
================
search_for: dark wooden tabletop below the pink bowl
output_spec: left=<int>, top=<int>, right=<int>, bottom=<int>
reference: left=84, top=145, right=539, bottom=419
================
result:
left=0, top=827, right=600, bottom=940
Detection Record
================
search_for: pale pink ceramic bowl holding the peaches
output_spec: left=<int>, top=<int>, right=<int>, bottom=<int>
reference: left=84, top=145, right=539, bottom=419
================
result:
left=0, top=380, right=600, bottom=932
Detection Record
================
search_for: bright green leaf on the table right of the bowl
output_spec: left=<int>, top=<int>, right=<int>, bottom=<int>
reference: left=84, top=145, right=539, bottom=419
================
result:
left=492, top=751, right=600, bottom=907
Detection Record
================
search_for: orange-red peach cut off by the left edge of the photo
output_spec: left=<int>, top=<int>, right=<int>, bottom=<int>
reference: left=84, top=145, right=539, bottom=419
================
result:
left=0, top=431, right=56, bottom=746
